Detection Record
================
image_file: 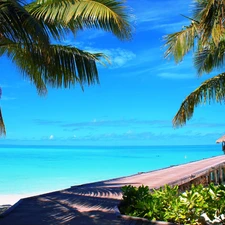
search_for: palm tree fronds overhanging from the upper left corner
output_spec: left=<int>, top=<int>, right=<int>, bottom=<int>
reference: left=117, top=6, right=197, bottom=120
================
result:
left=0, top=0, right=132, bottom=135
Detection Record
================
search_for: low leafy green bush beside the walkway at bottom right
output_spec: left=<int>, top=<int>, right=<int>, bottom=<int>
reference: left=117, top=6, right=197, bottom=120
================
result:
left=119, top=184, right=225, bottom=224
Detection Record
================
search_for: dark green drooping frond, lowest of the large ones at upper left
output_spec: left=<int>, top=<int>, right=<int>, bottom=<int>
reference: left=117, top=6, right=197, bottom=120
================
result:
left=0, top=40, right=105, bottom=95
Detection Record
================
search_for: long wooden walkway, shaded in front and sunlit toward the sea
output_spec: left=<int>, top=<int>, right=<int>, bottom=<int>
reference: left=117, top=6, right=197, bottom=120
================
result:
left=0, top=155, right=225, bottom=225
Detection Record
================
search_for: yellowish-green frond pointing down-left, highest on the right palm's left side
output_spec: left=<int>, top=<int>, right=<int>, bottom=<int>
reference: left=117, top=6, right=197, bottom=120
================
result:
left=164, top=21, right=198, bottom=63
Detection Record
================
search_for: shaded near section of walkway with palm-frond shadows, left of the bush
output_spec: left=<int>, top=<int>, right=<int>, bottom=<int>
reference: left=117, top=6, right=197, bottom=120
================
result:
left=0, top=181, right=143, bottom=225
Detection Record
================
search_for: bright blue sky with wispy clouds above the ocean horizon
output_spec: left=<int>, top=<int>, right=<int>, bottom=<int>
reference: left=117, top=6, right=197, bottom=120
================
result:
left=0, top=0, right=225, bottom=145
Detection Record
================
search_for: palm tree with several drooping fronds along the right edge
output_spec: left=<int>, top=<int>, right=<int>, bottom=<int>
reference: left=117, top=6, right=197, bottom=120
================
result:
left=165, top=0, right=225, bottom=127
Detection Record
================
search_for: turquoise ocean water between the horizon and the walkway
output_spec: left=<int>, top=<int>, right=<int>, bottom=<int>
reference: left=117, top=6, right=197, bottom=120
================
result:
left=0, top=144, right=223, bottom=195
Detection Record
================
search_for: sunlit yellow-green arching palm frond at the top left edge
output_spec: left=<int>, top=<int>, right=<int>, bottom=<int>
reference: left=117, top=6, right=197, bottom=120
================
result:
left=26, top=0, right=132, bottom=40
